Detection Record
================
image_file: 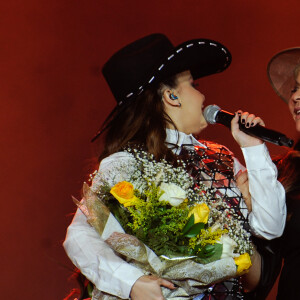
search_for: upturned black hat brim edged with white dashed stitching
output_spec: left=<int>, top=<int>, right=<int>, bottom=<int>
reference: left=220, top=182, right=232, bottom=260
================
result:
left=119, top=39, right=231, bottom=105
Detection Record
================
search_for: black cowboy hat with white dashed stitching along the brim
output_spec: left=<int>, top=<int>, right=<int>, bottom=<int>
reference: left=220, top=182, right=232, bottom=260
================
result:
left=102, top=33, right=231, bottom=105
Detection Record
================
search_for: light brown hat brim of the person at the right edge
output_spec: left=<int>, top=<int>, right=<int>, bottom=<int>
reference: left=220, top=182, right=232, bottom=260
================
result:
left=267, top=47, right=300, bottom=103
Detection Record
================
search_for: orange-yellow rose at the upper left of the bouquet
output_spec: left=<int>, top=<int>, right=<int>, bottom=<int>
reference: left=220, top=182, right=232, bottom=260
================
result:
left=110, top=181, right=138, bottom=207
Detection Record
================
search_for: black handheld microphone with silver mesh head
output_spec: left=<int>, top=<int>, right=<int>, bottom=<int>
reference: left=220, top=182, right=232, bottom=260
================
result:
left=203, top=105, right=294, bottom=147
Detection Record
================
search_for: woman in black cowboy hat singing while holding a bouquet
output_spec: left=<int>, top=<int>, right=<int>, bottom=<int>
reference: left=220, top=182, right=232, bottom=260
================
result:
left=64, top=34, right=285, bottom=300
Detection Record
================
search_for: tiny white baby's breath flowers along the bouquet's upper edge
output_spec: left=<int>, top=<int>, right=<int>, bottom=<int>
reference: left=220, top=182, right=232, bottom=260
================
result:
left=93, top=149, right=252, bottom=256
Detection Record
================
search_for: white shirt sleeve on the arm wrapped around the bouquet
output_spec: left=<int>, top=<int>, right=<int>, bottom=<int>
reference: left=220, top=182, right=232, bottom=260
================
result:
left=63, top=154, right=144, bottom=299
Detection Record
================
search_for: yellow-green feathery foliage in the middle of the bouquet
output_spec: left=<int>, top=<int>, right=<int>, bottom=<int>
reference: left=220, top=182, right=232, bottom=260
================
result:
left=125, top=184, right=189, bottom=255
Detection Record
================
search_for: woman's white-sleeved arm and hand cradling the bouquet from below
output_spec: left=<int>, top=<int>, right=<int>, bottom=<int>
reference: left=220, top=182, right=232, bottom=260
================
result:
left=64, top=153, right=174, bottom=300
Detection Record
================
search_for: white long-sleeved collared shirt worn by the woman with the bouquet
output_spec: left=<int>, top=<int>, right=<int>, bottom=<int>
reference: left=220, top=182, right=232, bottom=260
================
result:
left=63, top=129, right=286, bottom=299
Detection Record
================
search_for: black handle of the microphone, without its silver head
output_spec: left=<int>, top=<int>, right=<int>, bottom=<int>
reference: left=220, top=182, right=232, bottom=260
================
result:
left=215, top=111, right=294, bottom=148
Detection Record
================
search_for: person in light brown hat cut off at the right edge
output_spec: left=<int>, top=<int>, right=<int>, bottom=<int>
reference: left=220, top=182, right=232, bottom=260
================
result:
left=267, top=47, right=300, bottom=300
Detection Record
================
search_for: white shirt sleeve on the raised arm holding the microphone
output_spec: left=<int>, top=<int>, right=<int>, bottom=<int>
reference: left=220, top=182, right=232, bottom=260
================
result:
left=235, top=144, right=286, bottom=240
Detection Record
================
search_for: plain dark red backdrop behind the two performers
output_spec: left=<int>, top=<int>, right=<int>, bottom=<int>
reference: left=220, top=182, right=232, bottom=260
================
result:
left=0, top=0, right=300, bottom=300
